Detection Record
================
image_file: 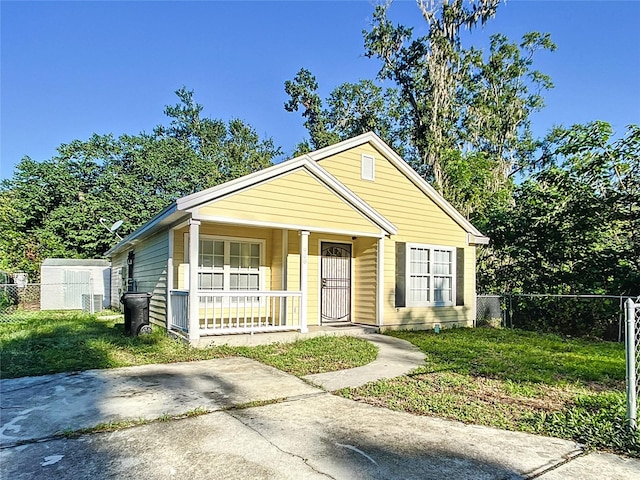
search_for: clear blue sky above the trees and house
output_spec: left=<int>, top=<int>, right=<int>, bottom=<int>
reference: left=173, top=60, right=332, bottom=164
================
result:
left=0, top=0, right=640, bottom=178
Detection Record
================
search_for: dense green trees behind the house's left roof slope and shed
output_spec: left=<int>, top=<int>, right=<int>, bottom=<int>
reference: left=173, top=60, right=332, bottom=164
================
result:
left=0, top=88, right=280, bottom=279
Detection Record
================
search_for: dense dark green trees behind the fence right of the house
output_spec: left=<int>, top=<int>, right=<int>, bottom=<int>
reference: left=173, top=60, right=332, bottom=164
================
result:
left=478, top=122, right=640, bottom=295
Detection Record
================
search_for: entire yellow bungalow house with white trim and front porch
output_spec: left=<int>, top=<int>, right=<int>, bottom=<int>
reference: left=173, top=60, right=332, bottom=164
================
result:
left=107, top=133, right=488, bottom=342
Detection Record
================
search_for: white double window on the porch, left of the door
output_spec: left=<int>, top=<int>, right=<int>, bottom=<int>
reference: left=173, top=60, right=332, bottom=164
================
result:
left=198, top=238, right=262, bottom=291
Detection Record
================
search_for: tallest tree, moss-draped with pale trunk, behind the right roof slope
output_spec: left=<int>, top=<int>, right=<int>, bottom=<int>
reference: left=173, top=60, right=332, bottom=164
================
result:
left=363, top=0, right=555, bottom=211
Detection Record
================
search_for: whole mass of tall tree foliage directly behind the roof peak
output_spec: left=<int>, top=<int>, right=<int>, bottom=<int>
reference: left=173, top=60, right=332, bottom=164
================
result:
left=285, top=0, right=555, bottom=221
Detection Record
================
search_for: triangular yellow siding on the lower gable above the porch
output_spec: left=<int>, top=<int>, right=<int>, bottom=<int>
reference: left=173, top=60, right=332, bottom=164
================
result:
left=198, top=170, right=380, bottom=234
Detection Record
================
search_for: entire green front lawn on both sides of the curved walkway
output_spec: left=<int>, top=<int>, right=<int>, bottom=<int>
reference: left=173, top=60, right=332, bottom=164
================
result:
left=0, top=312, right=640, bottom=457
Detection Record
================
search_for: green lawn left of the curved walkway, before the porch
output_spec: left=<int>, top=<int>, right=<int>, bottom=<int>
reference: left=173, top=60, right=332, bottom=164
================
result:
left=0, top=312, right=377, bottom=378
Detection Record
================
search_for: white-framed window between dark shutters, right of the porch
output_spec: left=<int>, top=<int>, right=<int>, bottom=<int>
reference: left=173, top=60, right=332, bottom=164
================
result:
left=405, top=243, right=456, bottom=307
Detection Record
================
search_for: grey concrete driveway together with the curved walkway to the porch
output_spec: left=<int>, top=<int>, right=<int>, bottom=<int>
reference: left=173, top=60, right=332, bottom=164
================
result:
left=0, top=335, right=640, bottom=480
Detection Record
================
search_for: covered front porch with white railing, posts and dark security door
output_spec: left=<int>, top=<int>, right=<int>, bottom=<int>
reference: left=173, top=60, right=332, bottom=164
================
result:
left=167, top=219, right=384, bottom=345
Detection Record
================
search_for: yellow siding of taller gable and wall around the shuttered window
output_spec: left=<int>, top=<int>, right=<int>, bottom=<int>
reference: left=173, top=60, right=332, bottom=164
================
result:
left=319, top=144, right=475, bottom=328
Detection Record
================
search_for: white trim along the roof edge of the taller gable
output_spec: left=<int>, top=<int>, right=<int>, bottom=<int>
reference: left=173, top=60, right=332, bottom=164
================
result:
left=306, top=132, right=489, bottom=244
